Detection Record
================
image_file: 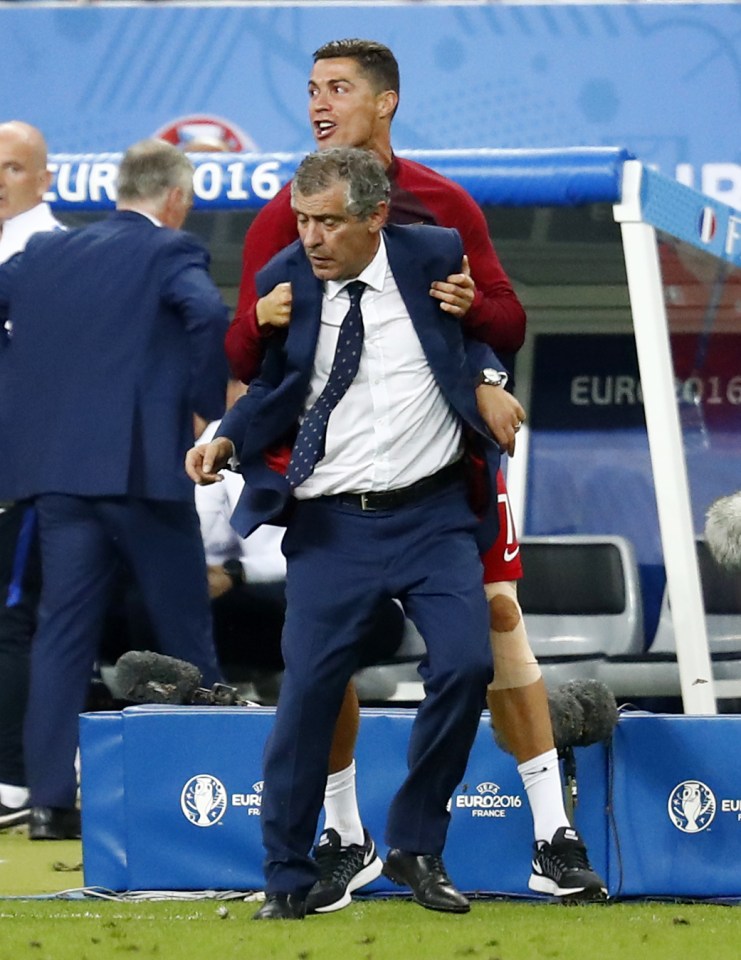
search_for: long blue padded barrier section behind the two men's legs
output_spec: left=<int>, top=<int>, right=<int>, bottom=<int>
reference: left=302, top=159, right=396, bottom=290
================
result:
left=80, top=706, right=607, bottom=896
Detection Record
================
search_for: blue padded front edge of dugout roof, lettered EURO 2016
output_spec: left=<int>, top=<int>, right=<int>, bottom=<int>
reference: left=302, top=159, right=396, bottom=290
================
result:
left=47, top=147, right=633, bottom=211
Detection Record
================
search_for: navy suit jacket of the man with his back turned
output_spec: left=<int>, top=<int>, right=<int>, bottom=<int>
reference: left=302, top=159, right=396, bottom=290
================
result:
left=0, top=211, right=228, bottom=501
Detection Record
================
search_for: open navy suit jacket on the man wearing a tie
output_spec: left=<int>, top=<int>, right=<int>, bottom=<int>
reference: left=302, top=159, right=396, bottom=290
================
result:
left=218, top=225, right=500, bottom=542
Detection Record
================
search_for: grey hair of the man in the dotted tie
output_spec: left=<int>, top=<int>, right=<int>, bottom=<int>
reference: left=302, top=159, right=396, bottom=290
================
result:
left=291, top=147, right=391, bottom=220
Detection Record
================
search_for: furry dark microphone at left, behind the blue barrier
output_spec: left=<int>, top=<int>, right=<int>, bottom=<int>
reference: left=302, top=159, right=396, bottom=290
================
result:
left=112, top=650, right=254, bottom=707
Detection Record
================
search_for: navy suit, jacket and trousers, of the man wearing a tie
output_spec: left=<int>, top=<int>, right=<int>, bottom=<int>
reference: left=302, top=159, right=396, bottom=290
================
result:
left=219, top=226, right=499, bottom=894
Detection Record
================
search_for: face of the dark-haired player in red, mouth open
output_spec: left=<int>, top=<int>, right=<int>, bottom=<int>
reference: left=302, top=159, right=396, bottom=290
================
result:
left=309, top=57, right=396, bottom=150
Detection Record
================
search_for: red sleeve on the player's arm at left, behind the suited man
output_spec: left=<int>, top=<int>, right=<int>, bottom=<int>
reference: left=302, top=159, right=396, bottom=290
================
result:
left=224, top=184, right=298, bottom=383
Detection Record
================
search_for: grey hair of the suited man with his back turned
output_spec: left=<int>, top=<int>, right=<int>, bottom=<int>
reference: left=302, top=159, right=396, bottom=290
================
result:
left=118, top=140, right=193, bottom=201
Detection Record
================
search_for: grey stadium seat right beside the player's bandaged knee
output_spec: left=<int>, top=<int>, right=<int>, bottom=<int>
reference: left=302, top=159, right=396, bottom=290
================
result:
left=519, top=535, right=644, bottom=687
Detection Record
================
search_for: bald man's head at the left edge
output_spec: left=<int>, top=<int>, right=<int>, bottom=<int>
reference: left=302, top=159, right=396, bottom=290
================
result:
left=0, top=120, right=51, bottom=224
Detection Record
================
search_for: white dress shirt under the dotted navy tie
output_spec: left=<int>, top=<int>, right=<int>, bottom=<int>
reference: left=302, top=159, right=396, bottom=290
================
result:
left=295, top=237, right=462, bottom=499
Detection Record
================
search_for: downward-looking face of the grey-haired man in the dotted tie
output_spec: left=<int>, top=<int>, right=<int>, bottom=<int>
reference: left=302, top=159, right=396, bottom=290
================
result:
left=293, top=182, right=387, bottom=280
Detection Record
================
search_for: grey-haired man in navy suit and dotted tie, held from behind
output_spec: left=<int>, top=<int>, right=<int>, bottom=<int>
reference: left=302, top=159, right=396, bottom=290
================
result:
left=186, top=148, right=521, bottom=919
